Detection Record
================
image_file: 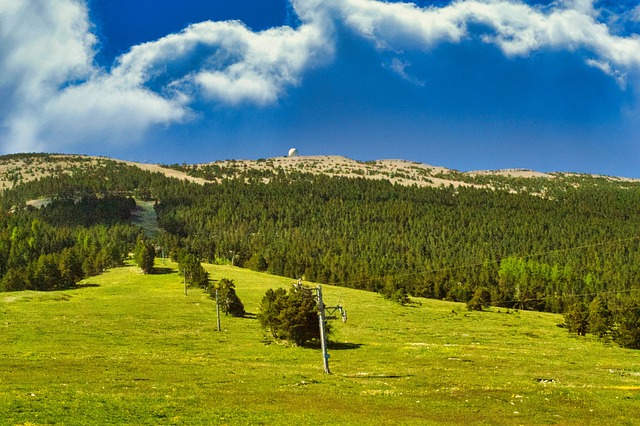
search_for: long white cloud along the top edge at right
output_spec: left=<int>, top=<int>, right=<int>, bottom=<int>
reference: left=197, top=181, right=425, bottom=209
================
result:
left=322, top=0, right=640, bottom=69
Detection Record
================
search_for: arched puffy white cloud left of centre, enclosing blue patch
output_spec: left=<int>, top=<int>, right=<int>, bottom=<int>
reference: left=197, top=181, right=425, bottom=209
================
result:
left=112, top=22, right=333, bottom=105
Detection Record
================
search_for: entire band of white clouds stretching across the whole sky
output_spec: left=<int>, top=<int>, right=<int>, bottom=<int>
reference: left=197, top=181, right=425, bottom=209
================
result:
left=0, top=0, right=640, bottom=151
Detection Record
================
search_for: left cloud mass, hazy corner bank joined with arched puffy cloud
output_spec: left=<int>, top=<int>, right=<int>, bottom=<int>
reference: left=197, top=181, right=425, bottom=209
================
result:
left=0, top=0, right=333, bottom=151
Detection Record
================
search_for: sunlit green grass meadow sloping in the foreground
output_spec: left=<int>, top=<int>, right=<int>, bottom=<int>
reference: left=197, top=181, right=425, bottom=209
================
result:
left=0, top=261, right=640, bottom=425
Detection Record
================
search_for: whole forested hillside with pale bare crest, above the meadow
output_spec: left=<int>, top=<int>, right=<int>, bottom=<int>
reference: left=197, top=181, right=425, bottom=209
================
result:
left=0, top=154, right=640, bottom=348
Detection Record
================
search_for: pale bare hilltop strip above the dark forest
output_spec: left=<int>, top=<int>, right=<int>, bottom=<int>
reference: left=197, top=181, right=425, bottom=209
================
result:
left=0, top=154, right=640, bottom=193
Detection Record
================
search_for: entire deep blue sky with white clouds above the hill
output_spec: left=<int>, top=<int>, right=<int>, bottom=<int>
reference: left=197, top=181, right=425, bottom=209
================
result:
left=0, top=0, right=640, bottom=178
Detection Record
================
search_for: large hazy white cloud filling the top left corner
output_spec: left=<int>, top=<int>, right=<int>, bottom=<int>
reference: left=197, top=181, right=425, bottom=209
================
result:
left=0, top=0, right=185, bottom=151
